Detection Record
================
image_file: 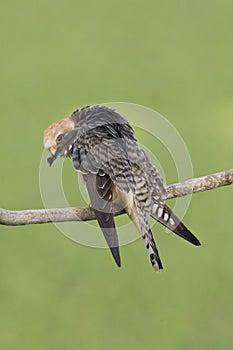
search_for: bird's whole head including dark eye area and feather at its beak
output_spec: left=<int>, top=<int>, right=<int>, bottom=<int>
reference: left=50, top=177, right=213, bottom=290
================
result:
left=43, top=118, right=75, bottom=165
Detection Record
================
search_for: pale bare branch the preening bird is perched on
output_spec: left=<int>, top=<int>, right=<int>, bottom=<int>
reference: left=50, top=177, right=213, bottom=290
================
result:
left=0, top=169, right=233, bottom=226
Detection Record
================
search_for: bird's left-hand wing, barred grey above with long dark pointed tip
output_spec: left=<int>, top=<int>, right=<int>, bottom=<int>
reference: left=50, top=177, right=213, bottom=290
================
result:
left=72, top=125, right=134, bottom=266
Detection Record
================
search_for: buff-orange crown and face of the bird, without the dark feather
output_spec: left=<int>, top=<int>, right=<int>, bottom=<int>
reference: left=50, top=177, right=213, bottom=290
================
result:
left=43, top=118, right=75, bottom=154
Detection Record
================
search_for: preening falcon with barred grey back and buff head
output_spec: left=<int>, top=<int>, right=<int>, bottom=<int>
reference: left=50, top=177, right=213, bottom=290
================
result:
left=43, top=105, right=201, bottom=271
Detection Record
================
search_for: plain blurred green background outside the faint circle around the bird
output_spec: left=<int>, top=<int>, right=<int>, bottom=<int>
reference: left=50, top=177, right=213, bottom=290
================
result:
left=0, top=0, right=233, bottom=350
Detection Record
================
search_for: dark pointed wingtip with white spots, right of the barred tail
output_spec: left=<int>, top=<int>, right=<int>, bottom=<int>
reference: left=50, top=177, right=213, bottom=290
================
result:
left=150, top=202, right=201, bottom=246
